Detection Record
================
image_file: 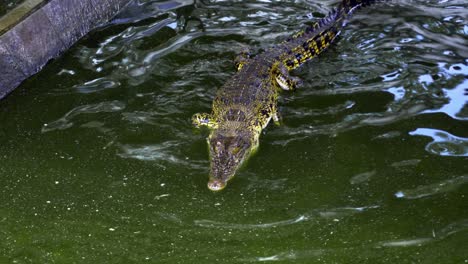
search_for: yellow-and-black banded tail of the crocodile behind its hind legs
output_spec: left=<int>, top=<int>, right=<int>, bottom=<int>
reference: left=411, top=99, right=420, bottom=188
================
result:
left=280, top=0, right=381, bottom=70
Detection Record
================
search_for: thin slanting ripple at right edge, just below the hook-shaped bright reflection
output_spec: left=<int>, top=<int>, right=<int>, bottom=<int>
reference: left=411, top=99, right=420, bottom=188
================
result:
left=395, top=176, right=468, bottom=200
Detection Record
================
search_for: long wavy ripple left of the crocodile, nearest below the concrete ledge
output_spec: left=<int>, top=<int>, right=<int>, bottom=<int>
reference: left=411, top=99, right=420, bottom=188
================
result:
left=41, top=101, right=125, bottom=133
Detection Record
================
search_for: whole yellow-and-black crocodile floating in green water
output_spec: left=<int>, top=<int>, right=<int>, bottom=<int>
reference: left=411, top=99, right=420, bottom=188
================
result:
left=192, top=0, right=376, bottom=191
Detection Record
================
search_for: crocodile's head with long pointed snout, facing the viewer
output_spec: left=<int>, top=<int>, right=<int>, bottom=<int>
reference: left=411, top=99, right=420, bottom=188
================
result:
left=208, top=129, right=258, bottom=191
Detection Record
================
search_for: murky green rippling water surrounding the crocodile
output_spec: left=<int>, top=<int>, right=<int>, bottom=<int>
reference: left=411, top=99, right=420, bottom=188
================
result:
left=0, top=1, right=468, bottom=263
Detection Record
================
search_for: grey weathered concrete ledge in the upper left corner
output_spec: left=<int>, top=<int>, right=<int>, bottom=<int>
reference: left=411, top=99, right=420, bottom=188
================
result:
left=0, top=0, right=131, bottom=99
